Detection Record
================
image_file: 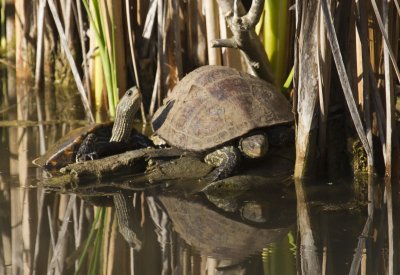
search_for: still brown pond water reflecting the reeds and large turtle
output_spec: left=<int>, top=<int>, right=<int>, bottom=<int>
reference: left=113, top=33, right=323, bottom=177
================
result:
left=0, top=123, right=397, bottom=275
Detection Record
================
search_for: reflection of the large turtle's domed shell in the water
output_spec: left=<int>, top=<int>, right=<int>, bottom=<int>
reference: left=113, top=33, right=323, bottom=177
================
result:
left=158, top=194, right=296, bottom=266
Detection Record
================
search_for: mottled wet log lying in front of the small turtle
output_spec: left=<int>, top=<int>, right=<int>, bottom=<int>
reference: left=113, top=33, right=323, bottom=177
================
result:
left=43, top=148, right=212, bottom=192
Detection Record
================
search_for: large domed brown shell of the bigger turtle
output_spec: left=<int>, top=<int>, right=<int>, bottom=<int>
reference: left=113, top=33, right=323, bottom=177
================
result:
left=152, top=66, right=294, bottom=151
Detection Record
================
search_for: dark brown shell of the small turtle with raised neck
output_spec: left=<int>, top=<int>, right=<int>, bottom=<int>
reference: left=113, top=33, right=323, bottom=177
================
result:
left=33, top=122, right=113, bottom=170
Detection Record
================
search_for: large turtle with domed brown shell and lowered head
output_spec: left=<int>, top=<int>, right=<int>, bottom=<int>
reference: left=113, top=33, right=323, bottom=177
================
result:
left=152, top=66, right=293, bottom=181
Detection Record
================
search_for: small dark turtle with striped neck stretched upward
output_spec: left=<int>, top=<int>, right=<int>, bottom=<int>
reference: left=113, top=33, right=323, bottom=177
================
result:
left=33, top=87, right=153, bottom=170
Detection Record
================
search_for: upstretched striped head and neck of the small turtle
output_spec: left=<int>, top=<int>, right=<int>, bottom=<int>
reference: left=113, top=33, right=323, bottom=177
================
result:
left=110, top=87, right=142, bottom=142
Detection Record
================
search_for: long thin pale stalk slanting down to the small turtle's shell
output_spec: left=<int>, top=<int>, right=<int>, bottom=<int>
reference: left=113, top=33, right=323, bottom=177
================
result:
left=47, top=0, right=94, bottom=123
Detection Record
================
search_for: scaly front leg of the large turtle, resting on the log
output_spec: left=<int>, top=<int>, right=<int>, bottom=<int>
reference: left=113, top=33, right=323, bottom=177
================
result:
left=204, top=146, right=241, bottom=181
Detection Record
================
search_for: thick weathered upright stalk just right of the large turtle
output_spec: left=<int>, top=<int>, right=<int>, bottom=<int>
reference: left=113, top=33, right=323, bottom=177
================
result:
left=294, top=1, right=319, bottom=178
